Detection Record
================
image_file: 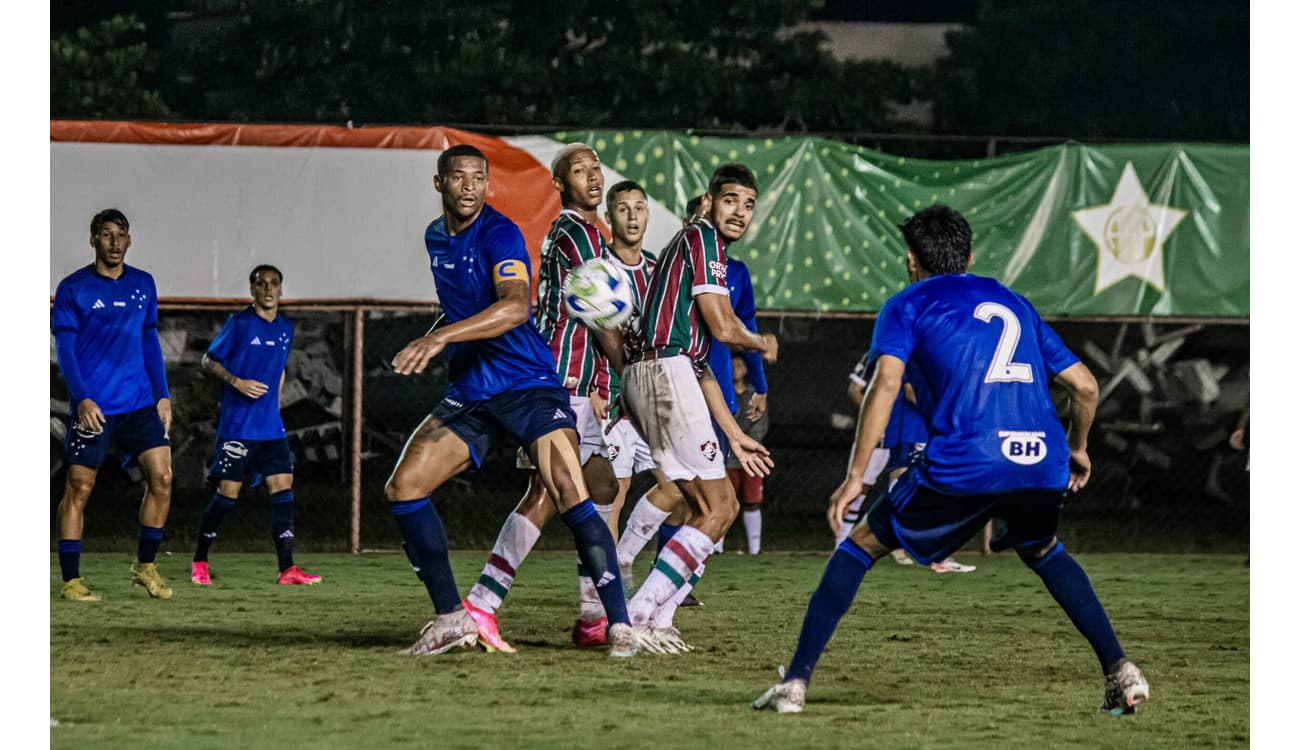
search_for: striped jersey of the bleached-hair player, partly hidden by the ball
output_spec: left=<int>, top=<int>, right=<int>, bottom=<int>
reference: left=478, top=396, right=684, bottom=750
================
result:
left=536, top=208, right=611, bottom=399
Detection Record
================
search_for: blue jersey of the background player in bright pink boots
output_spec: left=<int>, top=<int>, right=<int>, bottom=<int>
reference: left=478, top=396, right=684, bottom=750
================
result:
left=208, top=305, right=294, bottom=441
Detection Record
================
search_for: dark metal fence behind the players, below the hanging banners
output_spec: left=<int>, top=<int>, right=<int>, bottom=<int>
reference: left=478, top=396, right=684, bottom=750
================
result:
left=51, top=303, right=1249, bottom=554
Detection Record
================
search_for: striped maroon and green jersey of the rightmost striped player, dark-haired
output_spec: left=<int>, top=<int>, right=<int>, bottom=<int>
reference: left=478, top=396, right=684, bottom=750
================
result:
left=632, top=220, right=728, bottom=370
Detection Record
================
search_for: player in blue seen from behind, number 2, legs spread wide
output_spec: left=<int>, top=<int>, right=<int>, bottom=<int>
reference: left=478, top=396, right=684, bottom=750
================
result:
left=754, top=205, right=1151, bottom=714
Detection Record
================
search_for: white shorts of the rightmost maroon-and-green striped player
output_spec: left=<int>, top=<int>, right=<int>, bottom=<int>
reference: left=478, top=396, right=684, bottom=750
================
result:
left=623, top=356, right=727, bottom=480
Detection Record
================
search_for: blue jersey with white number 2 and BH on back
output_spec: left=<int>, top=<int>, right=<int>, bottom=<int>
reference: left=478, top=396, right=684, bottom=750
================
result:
left=867, top=274, right=1079, bottom=495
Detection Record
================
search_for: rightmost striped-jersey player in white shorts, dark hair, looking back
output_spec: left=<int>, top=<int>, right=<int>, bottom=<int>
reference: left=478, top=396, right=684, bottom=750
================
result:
left=623, top=164, right=777, bottom=649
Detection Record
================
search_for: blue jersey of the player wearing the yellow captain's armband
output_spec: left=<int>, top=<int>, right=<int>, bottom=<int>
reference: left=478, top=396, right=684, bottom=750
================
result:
left=424, top=204, right=559, bottom=402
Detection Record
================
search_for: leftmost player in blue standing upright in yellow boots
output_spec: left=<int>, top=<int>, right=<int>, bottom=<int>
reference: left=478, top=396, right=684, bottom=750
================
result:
left=51, top=208, right=172, bottom=602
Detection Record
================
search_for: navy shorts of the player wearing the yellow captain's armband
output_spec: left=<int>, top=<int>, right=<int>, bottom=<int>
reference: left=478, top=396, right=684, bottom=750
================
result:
left=432, top=386, right=577, bottom=467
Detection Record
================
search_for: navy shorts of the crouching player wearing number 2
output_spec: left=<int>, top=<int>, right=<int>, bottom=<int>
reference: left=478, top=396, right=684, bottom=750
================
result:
left=867, top=471, right=1065, bottom=563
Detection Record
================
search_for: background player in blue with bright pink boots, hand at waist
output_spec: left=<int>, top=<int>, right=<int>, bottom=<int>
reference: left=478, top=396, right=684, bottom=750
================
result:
left=190, top=265, right=321, bottom=586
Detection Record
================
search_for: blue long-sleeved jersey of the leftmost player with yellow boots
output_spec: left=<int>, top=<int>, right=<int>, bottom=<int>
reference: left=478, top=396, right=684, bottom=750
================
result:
left=49, top=264, right=168, bottom=416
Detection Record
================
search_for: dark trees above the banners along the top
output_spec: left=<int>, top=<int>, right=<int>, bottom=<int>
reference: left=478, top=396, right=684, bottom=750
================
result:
left=51, top=0, right=1249, bottom=140
